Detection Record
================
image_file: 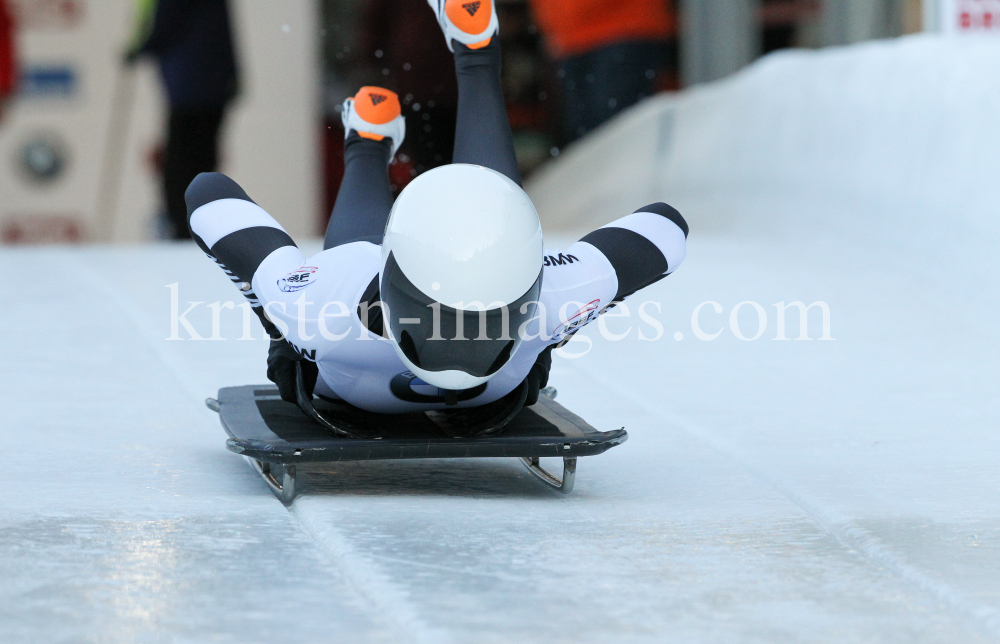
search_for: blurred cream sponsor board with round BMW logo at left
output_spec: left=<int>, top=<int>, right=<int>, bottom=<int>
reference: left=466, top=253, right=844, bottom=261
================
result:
left=0, top=0, right=320, bottom=245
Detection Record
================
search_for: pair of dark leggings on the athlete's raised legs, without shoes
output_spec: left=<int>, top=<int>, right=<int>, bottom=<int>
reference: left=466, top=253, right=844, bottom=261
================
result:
left=323, top=38, right=521, bottom=249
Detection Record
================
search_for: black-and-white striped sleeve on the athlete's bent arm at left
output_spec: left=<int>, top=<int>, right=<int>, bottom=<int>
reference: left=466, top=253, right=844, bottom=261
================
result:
left=184, top=172, right=302, bottom=338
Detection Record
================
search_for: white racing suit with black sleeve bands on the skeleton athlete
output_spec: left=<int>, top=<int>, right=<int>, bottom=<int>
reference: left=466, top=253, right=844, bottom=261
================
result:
left=189, top=175, right=687, bottom=413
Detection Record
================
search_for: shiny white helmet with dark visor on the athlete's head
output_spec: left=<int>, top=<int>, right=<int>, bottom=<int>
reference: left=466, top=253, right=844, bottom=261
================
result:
left=379, top=163, right=543, bottom=390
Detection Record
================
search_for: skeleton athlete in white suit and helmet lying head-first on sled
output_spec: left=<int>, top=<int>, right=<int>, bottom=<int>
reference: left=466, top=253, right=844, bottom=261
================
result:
left=186, top=0, right=688, bottom=430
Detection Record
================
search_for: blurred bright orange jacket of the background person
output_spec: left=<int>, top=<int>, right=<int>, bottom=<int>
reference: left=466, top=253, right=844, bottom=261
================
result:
left=530, top=0, right=677, bottom=58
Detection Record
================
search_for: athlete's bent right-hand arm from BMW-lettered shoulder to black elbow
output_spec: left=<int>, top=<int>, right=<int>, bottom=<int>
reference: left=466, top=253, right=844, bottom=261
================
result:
left=542, top=203, right=688, bottom=341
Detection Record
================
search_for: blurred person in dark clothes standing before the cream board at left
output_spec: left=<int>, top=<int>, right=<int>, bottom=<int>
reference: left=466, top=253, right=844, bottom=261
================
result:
left=126, top=0, right=238, bottom=239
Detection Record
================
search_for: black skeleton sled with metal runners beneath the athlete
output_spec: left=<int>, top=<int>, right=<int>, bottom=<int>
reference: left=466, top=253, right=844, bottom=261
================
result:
left=205, top=385, right=628, bottom=503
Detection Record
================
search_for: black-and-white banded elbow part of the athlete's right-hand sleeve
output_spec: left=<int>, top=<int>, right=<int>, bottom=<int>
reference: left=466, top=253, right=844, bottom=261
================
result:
left=580, top=203, right=688, bottom=302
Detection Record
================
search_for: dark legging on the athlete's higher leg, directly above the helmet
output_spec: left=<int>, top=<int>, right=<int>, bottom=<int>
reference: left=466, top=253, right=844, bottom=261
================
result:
left=453, top=37, right=521, bottom=185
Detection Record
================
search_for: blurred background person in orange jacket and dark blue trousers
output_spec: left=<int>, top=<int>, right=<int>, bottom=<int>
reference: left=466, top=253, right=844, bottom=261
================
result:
left=529, top=0, right=677, bottom=143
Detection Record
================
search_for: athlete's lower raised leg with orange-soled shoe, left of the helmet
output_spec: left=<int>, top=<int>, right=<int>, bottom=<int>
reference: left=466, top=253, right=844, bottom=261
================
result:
left=323, top=87, right=405, bottom=249
